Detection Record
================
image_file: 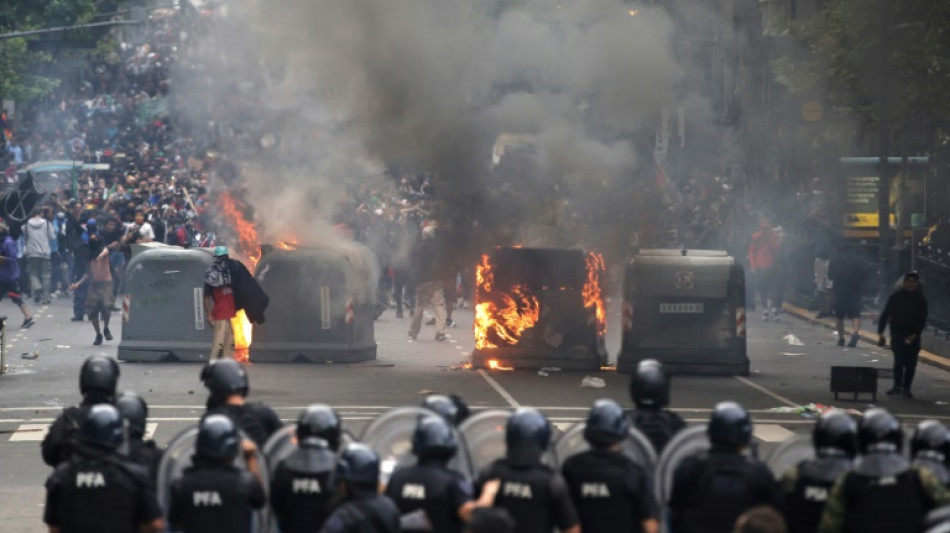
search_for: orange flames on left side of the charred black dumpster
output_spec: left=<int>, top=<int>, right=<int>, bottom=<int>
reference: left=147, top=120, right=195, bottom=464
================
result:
left=474, top=255, right=541, bottom=350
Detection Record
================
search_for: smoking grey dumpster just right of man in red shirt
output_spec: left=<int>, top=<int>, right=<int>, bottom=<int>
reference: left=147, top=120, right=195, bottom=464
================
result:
left=251, top=244, right=378, bottom=363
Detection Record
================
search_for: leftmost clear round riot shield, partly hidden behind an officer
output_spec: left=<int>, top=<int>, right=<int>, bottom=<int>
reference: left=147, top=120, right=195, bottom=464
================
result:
left=156, top=425, right=270, bottom=533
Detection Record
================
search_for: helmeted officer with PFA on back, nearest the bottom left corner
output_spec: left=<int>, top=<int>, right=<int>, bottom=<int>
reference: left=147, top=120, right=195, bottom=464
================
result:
left=43, top=404, right=165, bottom=533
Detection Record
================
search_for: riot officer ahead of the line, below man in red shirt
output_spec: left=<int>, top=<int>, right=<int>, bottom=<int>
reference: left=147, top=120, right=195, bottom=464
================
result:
left=201, top=358, right=283, bottom=447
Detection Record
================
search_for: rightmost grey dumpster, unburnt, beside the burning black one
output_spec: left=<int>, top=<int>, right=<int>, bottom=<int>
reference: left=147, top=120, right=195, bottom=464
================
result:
left=617, top=250, right=749, bottom=376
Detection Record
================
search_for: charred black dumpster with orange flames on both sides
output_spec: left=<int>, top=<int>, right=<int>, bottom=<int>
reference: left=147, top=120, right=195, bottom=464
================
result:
left=472, top=248, right=607, bottom=370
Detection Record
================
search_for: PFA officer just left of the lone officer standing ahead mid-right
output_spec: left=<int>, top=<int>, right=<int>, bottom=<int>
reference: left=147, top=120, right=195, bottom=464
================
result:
left=562, top=400, right=660, bottom=533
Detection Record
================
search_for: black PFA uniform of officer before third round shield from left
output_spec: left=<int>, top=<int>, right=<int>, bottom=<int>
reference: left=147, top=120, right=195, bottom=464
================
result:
left=386, top=459, right=473, bottom=533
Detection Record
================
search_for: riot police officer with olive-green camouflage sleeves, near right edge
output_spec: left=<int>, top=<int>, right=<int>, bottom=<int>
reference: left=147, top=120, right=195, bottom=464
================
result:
left=818, top=408, right=950, bottom=533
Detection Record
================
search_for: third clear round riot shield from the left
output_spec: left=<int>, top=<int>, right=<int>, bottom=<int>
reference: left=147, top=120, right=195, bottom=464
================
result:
left=360, top=407, right=474, bottom=485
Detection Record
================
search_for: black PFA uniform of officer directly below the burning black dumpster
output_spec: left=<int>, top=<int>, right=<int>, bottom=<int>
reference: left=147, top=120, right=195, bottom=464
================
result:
left=476, top=458, right=578, bottom=533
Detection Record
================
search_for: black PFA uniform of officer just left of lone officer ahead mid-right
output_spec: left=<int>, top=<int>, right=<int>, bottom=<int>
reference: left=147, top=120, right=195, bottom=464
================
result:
left=562, top=449, right=658, bottom=533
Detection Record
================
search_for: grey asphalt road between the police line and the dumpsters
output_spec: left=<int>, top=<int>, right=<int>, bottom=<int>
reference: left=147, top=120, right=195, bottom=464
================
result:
left=0, top=300, right=950, bottom=533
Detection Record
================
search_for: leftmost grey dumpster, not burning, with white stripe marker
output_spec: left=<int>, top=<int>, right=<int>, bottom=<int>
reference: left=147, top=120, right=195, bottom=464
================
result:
left=119, top=245, right=213, bottom=362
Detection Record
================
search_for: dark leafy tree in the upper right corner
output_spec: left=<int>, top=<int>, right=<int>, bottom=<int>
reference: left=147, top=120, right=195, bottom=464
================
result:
left=773, top=0, right=950, bottom=153
